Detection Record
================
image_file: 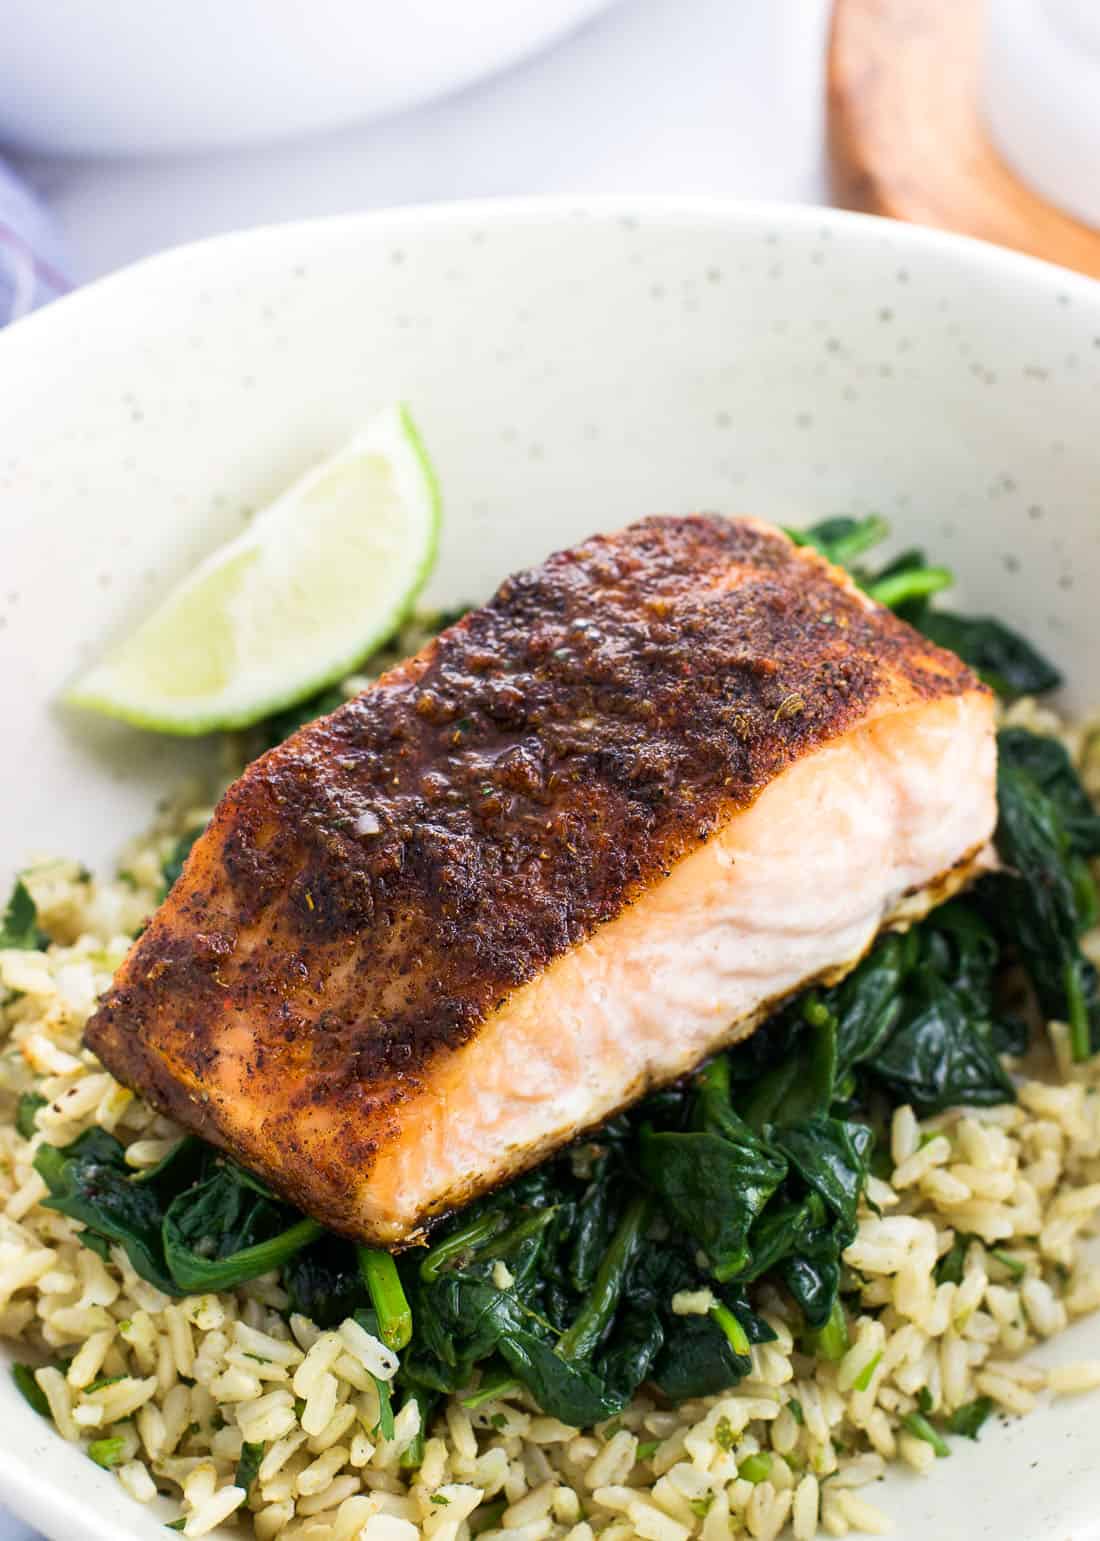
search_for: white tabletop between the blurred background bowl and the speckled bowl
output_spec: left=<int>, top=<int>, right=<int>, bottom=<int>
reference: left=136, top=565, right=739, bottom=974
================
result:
left=10, top=0, right=829, bottom=280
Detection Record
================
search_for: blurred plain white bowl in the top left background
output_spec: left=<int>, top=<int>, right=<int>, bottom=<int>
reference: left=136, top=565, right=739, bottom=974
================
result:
left=0, top=0, right=622, bottom=154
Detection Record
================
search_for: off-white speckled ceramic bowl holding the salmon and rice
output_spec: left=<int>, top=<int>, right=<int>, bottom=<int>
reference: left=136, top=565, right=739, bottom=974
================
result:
left=0, top=200, right=1100, bottom=1541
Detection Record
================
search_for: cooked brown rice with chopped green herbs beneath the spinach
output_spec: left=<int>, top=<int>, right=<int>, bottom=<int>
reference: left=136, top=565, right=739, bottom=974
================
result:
left=0, top=703, right=1100, bottom=1541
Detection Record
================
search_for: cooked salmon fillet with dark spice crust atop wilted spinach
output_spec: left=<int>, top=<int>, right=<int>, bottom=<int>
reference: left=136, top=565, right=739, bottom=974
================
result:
left=86, top=516, right=995, bottom=1247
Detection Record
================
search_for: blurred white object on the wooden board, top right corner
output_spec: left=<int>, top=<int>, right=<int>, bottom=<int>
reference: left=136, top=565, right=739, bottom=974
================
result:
left=983, top=0, right=1100, bottom=228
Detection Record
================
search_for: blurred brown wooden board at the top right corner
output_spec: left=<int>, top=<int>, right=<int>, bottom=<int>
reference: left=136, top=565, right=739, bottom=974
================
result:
left=829, top=0, right=1100, bottom=277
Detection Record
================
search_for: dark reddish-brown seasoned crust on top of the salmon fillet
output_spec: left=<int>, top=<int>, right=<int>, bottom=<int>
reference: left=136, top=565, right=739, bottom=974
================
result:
left=86, top=516, right=980, bottom=1224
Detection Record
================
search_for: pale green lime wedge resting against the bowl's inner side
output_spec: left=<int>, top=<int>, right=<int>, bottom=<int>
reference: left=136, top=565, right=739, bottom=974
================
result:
left=65, top=407, right=439, bottom=734
